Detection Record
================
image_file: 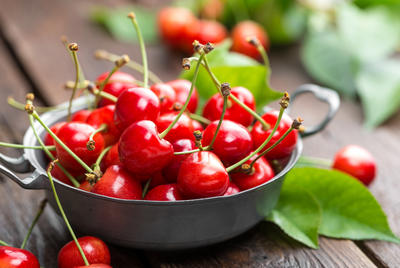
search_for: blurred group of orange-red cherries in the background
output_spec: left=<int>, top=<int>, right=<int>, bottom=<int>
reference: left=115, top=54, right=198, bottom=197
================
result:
left=157, top=7, right=269, bottom=59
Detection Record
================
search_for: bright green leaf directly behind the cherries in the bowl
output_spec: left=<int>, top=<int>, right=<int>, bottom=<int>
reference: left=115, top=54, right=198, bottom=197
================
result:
left=180, top=45, right=282, bottom=109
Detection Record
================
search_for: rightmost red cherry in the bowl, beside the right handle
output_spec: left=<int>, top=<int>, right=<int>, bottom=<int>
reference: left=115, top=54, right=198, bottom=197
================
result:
left=251, top=110, right=297, bottom=160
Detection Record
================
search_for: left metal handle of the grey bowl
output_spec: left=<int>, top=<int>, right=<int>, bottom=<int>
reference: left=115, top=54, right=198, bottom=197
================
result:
left=0, top=154, right=47, bottom=189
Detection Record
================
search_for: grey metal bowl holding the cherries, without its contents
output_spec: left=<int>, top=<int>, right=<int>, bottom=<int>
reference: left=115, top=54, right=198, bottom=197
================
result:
left=0, top=84, right=340, bottom=251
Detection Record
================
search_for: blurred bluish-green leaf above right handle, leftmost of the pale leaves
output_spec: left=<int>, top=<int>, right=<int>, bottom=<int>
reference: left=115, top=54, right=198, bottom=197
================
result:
left=302, top=23, right=356, bottom=98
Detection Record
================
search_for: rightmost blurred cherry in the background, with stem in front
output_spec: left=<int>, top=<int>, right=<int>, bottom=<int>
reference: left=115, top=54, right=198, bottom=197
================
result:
left=231, top=20, right=269, bottom=60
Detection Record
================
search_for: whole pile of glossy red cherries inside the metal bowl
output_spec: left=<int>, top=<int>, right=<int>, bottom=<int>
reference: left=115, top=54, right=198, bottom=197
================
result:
left=44, top=71, right=297, bottom=201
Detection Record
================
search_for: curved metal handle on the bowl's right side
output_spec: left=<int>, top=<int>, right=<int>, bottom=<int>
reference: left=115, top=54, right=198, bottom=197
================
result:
left=287, top=84, right=340, bottom=138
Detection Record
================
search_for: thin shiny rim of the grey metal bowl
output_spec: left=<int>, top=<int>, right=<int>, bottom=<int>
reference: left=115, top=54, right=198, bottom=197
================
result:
left=23, top=97, right=303, bottom=206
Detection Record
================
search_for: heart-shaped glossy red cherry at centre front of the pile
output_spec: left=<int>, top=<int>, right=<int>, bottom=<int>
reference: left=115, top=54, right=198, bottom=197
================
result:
left=118, top=120, right=174, bottom=175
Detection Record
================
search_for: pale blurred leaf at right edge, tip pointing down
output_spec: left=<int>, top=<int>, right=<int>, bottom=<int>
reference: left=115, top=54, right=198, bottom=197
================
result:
left=356, top=60, right=400, bottom=128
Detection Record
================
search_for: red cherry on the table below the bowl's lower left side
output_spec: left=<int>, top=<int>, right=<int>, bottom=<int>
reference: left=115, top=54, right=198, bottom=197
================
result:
left=57, top=236, right=111, bottom=268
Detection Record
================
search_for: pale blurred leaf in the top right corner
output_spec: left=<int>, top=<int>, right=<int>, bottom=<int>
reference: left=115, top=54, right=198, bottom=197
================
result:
left=337, top=3, right=400, bottom=63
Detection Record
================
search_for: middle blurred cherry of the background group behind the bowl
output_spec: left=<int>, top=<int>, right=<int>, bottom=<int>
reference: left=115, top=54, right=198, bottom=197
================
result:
left=192, top=20, right=228, bottom=46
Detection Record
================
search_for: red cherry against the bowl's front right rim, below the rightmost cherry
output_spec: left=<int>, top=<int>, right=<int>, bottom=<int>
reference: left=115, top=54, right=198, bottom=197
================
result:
left=231, top=154, right=275, bottom=191
